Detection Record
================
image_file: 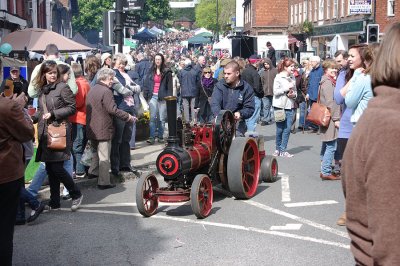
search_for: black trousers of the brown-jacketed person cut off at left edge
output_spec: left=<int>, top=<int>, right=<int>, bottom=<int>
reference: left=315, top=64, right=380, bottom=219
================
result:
left=0, top=177, right=24, bottom=265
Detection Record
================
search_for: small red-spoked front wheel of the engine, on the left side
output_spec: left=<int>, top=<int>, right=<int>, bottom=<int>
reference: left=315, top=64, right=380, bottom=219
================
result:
left=136, top=174, right=158, bottom=217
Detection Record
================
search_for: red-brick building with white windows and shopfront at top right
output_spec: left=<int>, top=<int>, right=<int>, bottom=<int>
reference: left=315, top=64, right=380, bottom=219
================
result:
left=288, top=0, right=400, bottom=58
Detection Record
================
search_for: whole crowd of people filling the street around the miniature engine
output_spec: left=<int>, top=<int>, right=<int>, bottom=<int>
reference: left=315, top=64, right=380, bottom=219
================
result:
left=0, top=23, right=400, bottom=265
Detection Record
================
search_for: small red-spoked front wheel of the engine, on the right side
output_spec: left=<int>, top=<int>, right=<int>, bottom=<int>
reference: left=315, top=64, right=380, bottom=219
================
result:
left=190, top=175, right=213, bottom=219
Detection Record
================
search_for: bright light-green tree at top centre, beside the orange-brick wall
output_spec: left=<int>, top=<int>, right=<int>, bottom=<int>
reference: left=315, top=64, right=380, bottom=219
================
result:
left=195, top=0, right=236, bottom=32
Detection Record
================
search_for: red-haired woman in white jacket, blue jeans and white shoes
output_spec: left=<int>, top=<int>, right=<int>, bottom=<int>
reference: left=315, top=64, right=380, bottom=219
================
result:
left=272, top=58, right=297, bottom=158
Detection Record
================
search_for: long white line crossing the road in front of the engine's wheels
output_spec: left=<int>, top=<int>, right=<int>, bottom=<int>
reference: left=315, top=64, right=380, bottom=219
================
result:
left=71, top=208, right=350, bottom=249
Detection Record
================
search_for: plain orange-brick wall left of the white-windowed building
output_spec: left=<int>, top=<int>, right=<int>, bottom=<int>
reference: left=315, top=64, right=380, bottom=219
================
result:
left=243, top=0, right=288, bottom=36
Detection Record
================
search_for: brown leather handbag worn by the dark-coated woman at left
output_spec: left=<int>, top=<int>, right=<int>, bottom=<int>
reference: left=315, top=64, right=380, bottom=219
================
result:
left=42, top=94, right=67, bottom=151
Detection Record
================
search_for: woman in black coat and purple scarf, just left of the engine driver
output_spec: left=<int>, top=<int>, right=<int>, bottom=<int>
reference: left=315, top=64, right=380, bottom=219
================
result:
left=197, top=67, right=218, bottom=123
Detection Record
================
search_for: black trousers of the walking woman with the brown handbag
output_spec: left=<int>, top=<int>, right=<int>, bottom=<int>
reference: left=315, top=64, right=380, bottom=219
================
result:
left=46, top=161, right=82, bottom=208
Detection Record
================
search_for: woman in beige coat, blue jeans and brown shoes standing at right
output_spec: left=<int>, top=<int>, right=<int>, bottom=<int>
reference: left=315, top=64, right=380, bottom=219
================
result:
left=319, top=59, right=340, bottom=180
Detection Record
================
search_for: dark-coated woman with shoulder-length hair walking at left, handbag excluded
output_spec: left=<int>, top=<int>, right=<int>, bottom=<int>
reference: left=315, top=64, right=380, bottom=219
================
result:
left=32, top=60, right=83, bottom=211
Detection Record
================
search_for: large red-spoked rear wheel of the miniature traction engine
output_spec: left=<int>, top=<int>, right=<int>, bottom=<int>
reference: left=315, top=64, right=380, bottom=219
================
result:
left=228, top=137, right=260, bottom=199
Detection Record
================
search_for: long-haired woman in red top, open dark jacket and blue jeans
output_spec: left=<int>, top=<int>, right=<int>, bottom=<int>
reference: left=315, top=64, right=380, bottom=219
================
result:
left=143, top=54, right=173, bottom=144
